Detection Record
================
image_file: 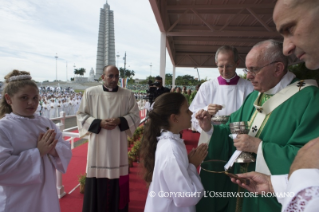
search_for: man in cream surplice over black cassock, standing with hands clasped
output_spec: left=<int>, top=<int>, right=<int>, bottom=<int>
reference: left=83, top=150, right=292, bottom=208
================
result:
left=77, top=66, right=140, bottom=212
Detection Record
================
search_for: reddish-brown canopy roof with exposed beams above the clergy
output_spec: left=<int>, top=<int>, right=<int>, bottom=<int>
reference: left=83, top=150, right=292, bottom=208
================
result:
left=149, top=0, right=297, bottom=67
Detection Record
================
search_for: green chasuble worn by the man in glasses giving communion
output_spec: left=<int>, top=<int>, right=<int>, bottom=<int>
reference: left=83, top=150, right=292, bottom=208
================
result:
left=196, top=79, right=319, bottom=212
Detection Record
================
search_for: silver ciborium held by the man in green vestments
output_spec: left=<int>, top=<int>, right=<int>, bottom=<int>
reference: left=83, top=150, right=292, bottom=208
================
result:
left=229, top=121, right=256, bottom=163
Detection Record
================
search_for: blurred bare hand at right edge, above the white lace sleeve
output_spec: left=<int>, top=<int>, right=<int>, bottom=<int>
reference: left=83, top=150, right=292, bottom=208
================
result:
left=289, top=137, right=319, bottom=177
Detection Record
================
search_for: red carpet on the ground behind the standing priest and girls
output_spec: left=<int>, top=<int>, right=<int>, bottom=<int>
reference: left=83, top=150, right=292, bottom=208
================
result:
left=60, top=130, right=199, bottom=212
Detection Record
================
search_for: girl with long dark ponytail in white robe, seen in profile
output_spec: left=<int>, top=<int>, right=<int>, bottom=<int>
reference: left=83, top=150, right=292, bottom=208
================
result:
left=141, top=93, right=207, bottom=212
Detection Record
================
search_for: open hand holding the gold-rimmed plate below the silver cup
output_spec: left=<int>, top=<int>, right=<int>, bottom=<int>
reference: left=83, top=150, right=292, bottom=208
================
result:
left=231, top=172, right=274, bottom=194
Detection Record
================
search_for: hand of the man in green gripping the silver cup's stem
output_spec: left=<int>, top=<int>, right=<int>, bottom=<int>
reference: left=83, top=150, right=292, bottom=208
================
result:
left=234, top=134, right=261, bottom=154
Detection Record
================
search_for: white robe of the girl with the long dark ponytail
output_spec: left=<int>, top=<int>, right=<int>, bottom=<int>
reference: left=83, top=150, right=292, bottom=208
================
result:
left=144, top=132, right=204, bottom=212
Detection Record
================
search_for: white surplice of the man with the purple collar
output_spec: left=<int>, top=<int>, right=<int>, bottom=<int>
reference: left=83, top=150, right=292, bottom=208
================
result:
left=189, top=78, right=253, bottom=132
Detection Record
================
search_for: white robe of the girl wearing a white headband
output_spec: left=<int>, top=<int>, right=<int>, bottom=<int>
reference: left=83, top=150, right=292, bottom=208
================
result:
left=0, top=113, right=72, bottom=212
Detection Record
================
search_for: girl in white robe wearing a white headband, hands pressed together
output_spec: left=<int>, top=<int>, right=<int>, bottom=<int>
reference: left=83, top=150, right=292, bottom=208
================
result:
left=0, top=70, right=72, bottom=212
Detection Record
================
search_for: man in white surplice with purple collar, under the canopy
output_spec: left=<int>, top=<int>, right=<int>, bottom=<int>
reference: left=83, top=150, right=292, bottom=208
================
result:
left=189, top=46, right=254, bottom=132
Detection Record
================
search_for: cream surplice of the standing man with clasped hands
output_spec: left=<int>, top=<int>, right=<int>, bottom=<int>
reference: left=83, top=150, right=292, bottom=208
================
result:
left=77, top=85, right=140, bottom=179
